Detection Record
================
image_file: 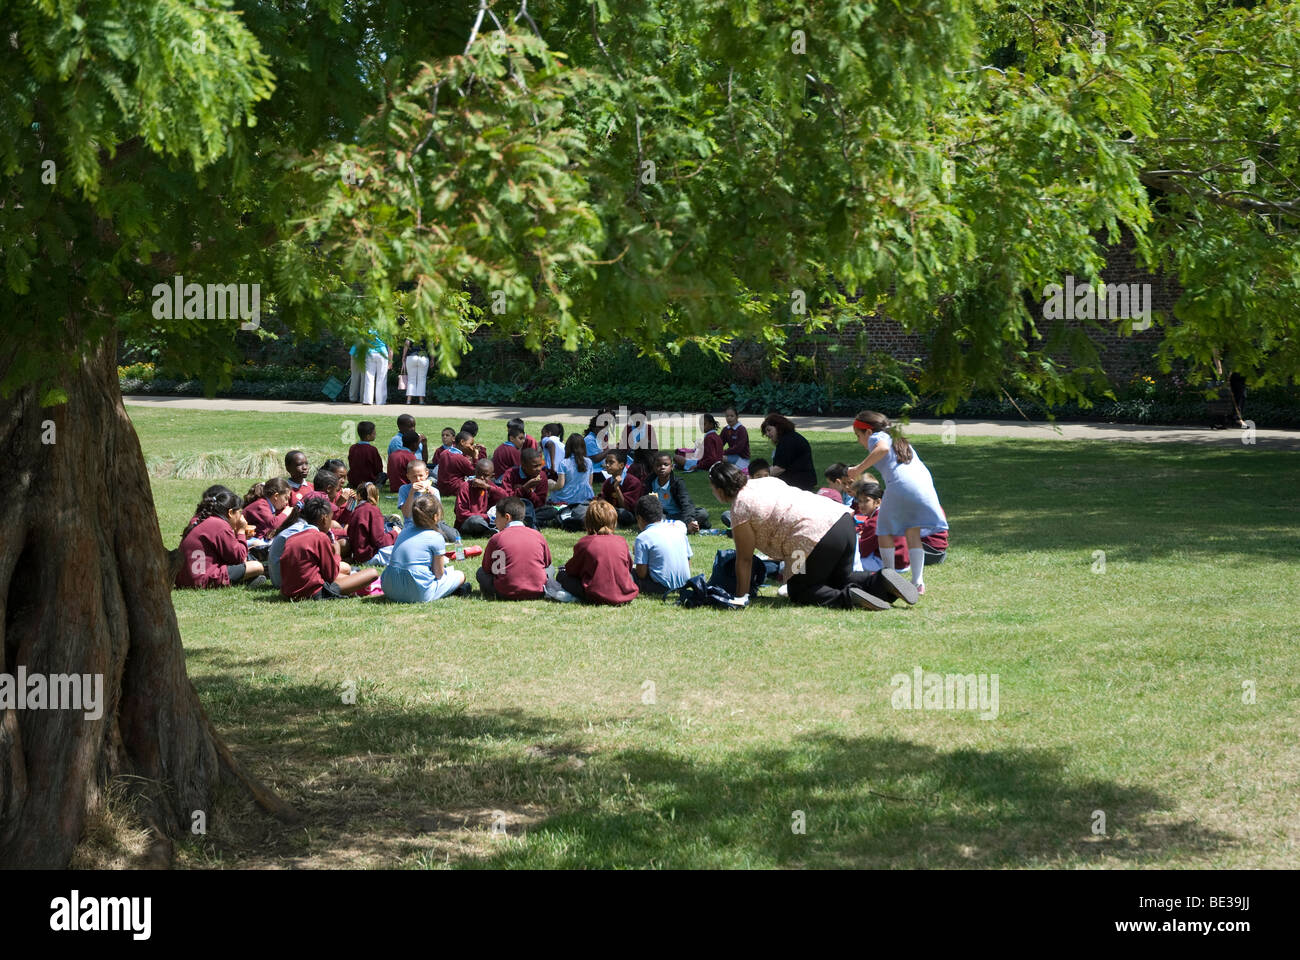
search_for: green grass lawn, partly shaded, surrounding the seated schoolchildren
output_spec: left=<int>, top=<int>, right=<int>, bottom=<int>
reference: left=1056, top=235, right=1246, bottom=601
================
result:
left=130, top=407, right=1300, bottom=868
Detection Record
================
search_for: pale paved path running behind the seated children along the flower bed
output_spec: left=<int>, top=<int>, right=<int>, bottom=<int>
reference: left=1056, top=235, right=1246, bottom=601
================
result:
left=124, top=397, right=1300, bottom=450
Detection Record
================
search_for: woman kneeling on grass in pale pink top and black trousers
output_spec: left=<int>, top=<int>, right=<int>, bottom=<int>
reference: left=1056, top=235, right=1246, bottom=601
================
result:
left=709, top=462, right=917, bottom=610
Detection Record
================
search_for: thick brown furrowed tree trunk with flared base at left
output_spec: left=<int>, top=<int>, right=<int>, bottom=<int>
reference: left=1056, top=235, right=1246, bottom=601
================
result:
left=0, top=341, right=294, bottom=866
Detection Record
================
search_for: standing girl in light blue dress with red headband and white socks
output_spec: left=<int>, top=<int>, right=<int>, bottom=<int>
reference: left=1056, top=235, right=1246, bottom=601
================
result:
left=849, top=410, right=948, bottom=593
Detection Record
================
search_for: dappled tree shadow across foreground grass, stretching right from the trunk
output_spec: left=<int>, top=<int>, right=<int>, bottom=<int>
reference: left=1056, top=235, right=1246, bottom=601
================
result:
left=178, top=655, right=1238, bottom=868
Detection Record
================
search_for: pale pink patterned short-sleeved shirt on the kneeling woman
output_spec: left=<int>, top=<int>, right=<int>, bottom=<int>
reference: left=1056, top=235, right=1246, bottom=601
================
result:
left=732, top=476, right=850, bottom=562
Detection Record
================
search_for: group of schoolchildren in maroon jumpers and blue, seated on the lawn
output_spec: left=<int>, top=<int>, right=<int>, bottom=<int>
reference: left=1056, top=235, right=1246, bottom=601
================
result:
left=176, top=408, right=948, bottom=604
